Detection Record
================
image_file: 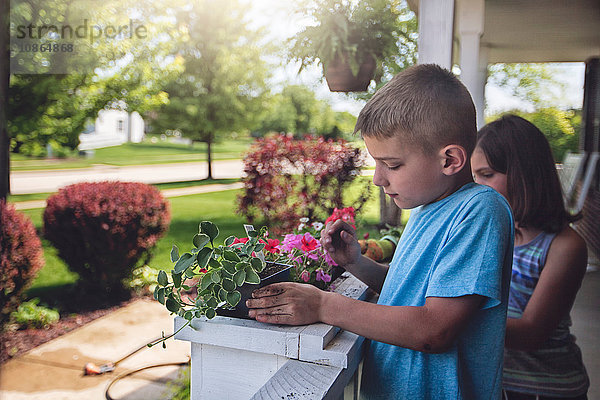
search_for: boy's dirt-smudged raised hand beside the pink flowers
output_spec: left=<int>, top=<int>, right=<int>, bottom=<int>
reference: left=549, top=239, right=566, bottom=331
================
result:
left=321, top=219, right=361, bottom=268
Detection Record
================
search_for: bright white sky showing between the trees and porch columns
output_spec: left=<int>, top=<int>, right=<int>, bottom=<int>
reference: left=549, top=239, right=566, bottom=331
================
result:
left=244, top=0, right=585, bottom=115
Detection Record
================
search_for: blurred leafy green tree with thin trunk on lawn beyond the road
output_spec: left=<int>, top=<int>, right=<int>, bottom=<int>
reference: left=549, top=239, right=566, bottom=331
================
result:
left=153, top=0, right=267, bottom=179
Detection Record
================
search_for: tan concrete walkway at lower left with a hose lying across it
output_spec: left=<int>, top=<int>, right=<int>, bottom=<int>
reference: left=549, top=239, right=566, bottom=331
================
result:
left=0, top=300, right=190, bottom=400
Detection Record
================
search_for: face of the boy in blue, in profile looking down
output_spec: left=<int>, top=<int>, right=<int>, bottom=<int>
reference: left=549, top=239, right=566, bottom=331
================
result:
left=364, top=137, right=449, bottom=209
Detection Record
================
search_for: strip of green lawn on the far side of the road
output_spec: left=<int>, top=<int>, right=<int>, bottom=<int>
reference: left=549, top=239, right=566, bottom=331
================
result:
left=11, top=137, right=254, bottom=171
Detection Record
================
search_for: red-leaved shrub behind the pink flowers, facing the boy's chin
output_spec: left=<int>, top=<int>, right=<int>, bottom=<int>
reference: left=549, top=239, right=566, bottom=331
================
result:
left=238, top=135, right=370, bottom=233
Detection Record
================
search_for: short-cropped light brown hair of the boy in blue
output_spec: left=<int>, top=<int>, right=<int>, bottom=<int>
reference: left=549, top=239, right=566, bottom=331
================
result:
left=354, top=64, right=477, bottom=156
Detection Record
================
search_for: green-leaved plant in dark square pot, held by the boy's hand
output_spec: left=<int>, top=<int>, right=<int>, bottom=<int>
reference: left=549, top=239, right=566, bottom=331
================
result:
left=148, top=221, right=291, bottom=346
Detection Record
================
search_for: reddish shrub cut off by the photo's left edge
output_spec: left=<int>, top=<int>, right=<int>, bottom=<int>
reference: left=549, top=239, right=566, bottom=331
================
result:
left=0, top=201, right=44, bottom=323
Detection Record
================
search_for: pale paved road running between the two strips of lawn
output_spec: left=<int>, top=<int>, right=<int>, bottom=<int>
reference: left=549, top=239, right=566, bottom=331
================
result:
left=10, top=160, right=244, bottom=194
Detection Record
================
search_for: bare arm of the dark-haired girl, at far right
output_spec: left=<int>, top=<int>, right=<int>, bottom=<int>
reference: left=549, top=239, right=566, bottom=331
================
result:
left=506, top=227, right=587, bottom=350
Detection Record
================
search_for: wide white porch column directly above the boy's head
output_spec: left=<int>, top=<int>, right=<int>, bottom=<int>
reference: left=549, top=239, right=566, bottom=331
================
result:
left=418, top=0, right=454, bottom=69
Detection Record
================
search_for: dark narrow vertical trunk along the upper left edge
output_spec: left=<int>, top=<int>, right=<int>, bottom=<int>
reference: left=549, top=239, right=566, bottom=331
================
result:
left=0, top=0, right=10, bottom=200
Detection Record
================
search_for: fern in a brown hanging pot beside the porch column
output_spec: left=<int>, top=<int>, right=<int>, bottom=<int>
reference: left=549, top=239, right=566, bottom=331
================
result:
left=290, top=0, right=401, bottom=92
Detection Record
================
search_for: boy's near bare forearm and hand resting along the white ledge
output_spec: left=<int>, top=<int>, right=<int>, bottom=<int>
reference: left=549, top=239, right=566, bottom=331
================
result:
left=248, top=283, right=484, bottom=353
